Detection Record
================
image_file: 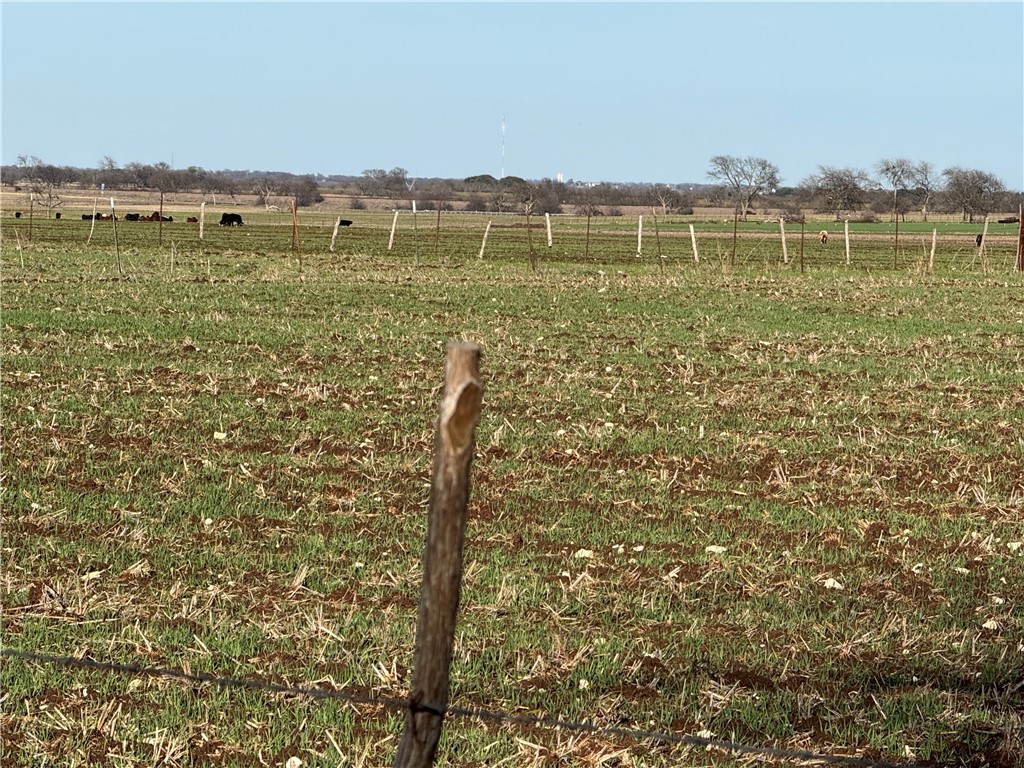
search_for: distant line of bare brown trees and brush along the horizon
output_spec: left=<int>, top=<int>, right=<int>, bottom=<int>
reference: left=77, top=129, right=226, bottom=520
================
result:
left=0, top=157, right=1022, bottom=220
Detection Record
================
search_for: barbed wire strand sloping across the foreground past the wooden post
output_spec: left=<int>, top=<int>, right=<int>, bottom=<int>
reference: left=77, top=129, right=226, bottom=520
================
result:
left=0, top=648, right=925, bottom=768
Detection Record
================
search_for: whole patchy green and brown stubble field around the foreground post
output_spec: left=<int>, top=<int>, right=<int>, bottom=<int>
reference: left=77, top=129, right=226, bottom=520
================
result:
left=0, top=217, right=1024, bottom=768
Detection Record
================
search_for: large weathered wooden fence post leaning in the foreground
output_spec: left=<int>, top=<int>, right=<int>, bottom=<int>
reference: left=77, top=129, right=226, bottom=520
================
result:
left=392, top=342, right=483, bottom=768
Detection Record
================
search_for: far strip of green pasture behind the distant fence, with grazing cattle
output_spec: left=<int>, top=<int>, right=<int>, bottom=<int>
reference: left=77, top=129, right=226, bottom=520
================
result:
left=5, top=207, right=1017, bottom=274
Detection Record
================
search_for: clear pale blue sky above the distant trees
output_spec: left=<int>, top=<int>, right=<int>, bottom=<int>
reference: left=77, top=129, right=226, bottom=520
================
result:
left=0, top=0, right=1024, bottom=189
